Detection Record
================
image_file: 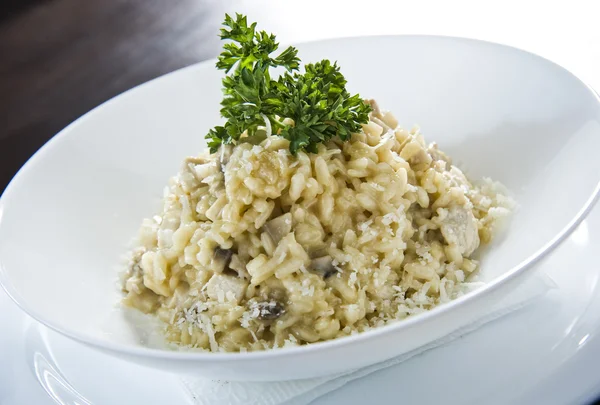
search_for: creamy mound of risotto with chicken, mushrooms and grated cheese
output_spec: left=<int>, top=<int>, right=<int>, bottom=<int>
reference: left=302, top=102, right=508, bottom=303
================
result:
left=123, top=101, right=513, bottom=352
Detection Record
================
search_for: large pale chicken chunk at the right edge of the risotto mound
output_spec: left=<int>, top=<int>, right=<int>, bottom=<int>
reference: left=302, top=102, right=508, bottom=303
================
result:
left=440, top=205, right=479, bottom=257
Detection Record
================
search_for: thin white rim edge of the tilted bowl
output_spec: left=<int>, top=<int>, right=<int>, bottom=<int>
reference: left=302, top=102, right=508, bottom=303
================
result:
left=0, top=35, right=600, bottom=363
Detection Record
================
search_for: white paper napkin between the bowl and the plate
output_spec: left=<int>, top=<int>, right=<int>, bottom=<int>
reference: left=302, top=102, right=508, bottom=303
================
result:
left=182, top=273, right=556, bottom=405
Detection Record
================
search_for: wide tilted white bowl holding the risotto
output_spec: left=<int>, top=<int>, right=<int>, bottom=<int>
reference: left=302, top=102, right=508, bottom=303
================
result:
left=0, top=36, right=600, bottom=380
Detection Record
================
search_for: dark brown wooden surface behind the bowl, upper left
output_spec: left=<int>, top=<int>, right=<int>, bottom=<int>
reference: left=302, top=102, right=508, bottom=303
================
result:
left=0, top=0, right=600, bottom=404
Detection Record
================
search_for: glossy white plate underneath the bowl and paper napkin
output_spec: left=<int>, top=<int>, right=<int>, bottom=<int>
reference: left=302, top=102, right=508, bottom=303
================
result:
left=0, top=207, right=600, bottom=405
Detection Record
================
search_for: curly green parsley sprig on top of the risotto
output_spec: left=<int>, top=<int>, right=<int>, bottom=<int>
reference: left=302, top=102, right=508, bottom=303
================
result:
left=206, top=14, right=371, bottom=154
